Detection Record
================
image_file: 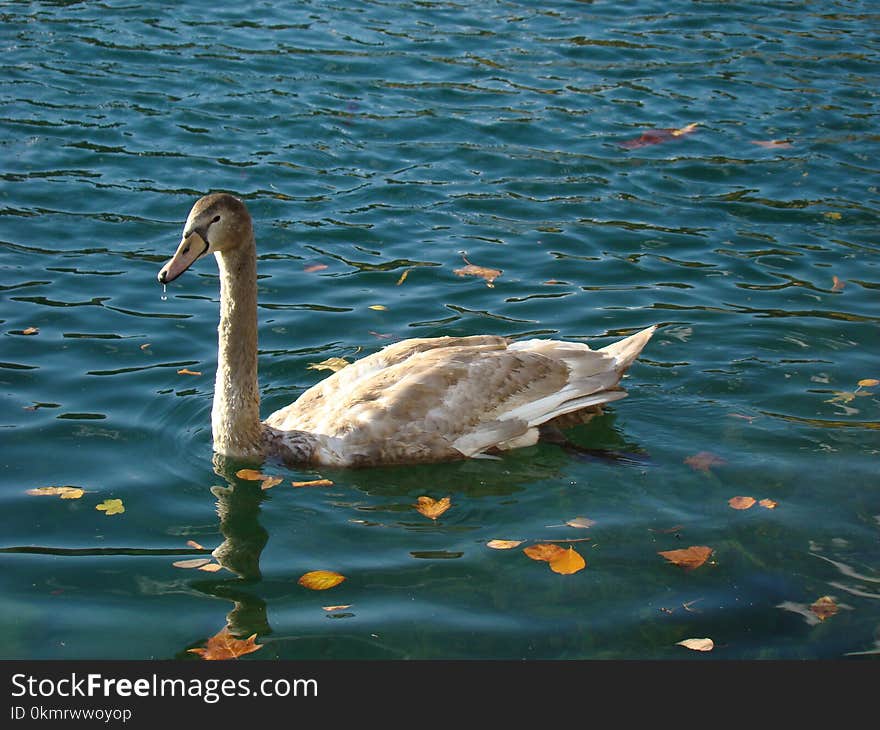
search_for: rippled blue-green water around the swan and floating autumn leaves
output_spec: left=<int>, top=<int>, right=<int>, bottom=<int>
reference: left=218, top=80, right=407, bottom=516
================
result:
left=0, top=0, right=880, bottom=661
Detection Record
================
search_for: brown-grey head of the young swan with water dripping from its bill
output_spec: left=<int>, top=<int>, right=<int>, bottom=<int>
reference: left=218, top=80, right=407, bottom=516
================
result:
left=158, top=193, right=253, bottom=284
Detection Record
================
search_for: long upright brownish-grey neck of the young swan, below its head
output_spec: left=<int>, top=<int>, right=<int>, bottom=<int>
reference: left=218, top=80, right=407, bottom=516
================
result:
left=211, top=236, right=262, bottom=458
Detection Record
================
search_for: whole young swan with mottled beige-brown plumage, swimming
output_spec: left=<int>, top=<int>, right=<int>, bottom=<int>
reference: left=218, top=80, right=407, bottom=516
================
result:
left=158, top=193, right=656, bottom=467
